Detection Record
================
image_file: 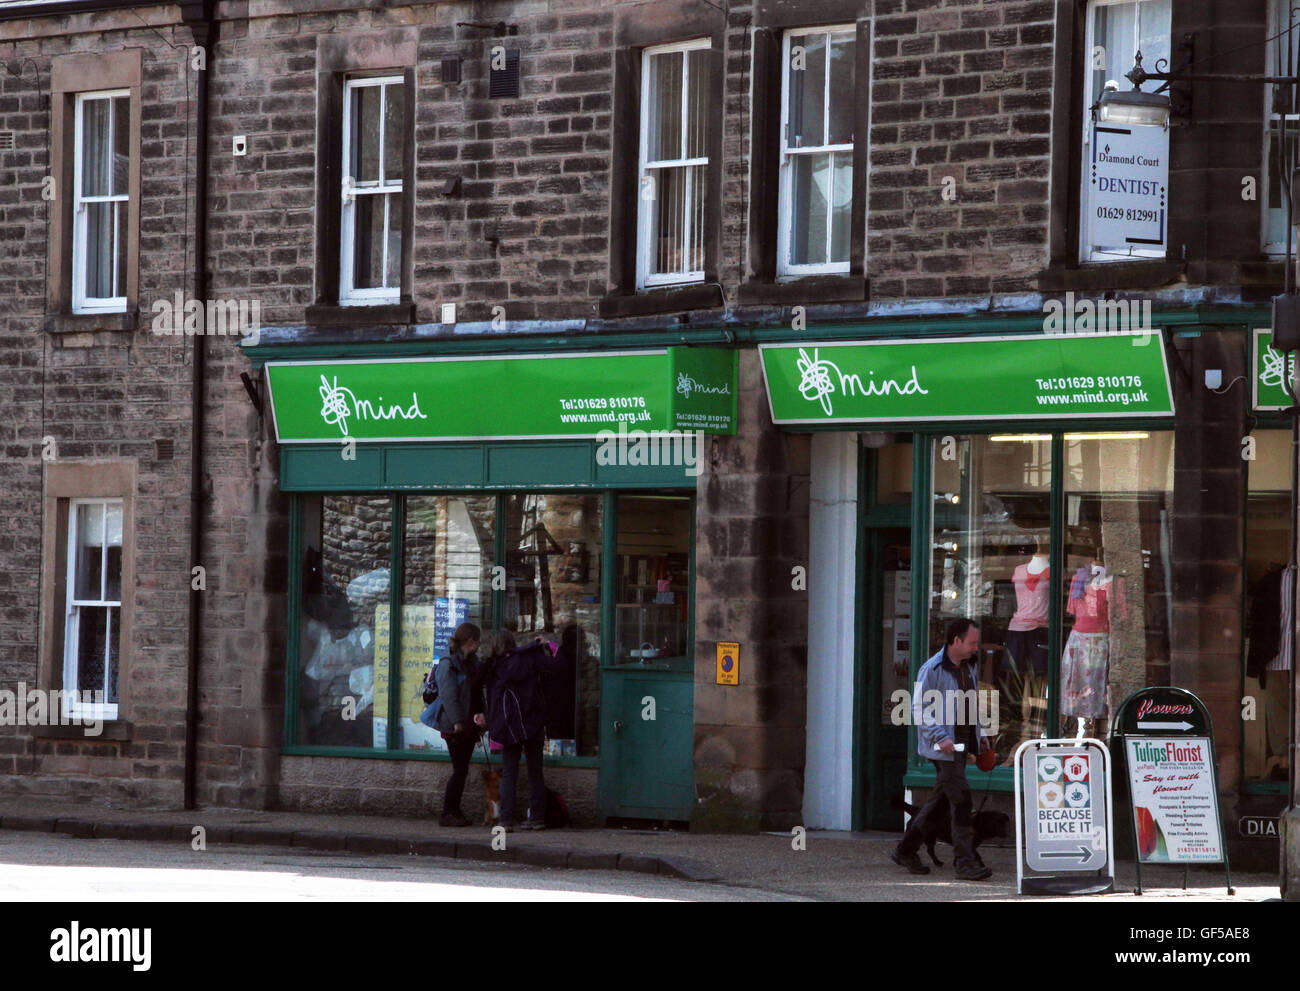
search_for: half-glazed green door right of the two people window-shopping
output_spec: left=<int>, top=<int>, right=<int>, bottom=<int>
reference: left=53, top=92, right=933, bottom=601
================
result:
left=599, top=494, right=694, bottom=822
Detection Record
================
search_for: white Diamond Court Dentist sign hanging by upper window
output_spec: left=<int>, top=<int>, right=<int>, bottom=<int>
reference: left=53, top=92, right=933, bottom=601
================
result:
left=1087, top=122, right=1169, bottom=256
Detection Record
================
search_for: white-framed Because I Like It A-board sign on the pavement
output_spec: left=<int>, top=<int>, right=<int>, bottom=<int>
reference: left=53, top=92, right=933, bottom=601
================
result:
left=1015, top=740, right=1114, bottom=893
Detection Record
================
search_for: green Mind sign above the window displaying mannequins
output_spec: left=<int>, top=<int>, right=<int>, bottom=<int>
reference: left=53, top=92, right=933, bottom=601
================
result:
left=759, top=330, right=1174, bottom=425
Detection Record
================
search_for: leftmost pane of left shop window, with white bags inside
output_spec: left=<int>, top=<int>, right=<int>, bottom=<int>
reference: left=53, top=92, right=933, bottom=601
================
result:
left=298, top=496, right=391, bottom=747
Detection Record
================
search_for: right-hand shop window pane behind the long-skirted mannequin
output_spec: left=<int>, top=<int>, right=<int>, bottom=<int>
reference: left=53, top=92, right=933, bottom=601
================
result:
left=1058, top=432, right=1174, bottom=739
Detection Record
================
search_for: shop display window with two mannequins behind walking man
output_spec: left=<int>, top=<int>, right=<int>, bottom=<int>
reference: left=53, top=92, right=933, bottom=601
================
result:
left=927, top=430, right=1174, bottom=766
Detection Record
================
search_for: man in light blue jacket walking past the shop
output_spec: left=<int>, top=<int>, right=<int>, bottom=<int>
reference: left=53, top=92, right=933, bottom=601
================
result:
left=889, top=619, right=993, bottom=880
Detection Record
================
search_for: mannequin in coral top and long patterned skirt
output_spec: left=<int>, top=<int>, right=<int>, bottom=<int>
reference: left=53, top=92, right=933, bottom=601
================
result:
left=1061, top=548, right=1126, bottom=726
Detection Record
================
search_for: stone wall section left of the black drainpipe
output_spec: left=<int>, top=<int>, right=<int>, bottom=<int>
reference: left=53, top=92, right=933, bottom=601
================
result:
left=0, top=12, right=202, bottom=805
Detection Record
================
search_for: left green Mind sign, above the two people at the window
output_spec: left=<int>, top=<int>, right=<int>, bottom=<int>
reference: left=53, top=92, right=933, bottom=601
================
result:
left=267, top=347, right=738, bottom=443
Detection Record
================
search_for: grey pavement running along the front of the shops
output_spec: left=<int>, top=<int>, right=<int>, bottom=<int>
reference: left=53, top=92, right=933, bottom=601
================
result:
left=0, top=796, right=1279, bottom=903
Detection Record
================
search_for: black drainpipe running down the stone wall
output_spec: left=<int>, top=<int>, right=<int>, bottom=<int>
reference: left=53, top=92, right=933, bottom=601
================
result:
left=181, top=0, right=217, bottom=809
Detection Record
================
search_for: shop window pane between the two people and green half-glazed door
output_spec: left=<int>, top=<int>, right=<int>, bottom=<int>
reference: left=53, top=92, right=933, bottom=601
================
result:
left=504, top=494, right=603, bottom=757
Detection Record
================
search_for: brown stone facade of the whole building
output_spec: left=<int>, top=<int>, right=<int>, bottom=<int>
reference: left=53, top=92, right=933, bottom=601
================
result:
left=0, top=0, right=1282, bottom=863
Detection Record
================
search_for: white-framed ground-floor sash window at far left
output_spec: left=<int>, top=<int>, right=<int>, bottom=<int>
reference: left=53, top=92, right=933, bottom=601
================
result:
left=64, top=499, right=122, bottom=719
